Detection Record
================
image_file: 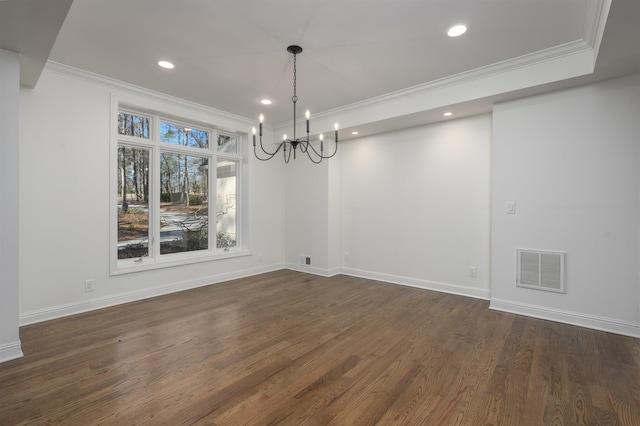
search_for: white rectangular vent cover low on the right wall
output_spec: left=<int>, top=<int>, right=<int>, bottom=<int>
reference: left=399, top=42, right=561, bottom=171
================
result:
left=516, top=249, right=567, bottom=293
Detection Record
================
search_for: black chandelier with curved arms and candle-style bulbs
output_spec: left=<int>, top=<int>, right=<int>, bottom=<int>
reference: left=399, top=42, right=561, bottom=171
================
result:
left=253, top=45, right=338, bottom=164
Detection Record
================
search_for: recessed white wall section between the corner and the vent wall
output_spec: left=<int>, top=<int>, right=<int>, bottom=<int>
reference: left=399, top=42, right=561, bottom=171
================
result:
left=339, top=115, right=491, bottom=298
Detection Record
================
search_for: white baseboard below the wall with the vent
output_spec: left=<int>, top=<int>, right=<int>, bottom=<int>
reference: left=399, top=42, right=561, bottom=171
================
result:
left=489, top=299, right=640, bottom=338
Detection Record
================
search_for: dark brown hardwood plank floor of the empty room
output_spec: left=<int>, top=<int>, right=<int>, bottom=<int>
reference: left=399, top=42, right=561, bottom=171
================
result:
left=0, top=270, right=640, bottom=426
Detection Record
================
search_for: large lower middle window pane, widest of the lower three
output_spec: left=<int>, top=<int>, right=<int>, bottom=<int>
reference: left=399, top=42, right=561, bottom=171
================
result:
left=160, top=152, right=209, bottom=254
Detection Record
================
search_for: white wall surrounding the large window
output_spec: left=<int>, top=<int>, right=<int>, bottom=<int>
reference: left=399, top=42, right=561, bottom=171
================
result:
left=19, top=65, right=284, bottom=324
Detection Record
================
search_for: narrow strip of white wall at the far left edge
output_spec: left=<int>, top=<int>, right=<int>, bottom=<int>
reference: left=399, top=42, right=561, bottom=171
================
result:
left=0, top=50, right=22, bottom=362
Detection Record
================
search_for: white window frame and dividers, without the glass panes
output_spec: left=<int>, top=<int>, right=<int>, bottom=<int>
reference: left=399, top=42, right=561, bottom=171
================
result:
left=109, top=95, right=250, bottom=275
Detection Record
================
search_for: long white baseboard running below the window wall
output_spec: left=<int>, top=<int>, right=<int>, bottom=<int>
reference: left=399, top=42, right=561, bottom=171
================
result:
left=18, top=264, right=284, bottom=326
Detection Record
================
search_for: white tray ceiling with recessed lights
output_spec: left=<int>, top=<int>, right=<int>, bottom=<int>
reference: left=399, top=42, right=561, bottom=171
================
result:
left=0, top=0, right=640, bottom=138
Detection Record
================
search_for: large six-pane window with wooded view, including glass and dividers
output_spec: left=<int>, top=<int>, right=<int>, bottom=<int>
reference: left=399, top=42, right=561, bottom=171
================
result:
left=111, top=107, right=243, bottom=273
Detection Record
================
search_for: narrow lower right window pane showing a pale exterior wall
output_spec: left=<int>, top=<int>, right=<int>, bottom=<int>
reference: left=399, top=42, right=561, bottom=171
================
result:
left=216, top=160, right=238, bottom=250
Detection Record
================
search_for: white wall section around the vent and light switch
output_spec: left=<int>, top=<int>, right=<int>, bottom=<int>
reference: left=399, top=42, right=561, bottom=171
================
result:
left=491, top=75, right=640, bottom=337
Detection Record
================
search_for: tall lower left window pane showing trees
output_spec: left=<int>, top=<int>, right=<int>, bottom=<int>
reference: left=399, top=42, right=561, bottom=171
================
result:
left=117, top=146, right=149, bottom=259
